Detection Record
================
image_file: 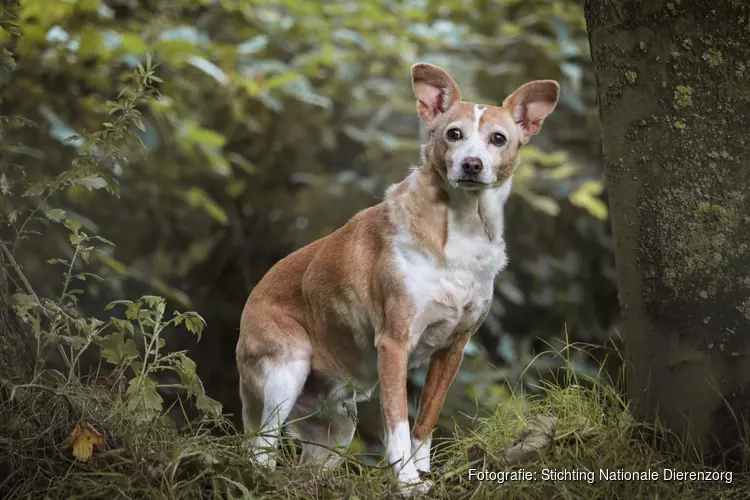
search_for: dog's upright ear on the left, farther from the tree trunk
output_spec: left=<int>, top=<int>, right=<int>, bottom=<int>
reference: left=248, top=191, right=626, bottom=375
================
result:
left=411, top=63, right=461, bottom=125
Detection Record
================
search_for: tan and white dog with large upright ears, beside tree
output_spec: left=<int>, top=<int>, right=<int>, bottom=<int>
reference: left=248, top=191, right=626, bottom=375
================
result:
left=237, top=64, right=559, bottom=493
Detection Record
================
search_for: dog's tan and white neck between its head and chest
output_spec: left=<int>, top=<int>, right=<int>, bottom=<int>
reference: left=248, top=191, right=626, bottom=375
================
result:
left=386, top=164, right=511, bottom=260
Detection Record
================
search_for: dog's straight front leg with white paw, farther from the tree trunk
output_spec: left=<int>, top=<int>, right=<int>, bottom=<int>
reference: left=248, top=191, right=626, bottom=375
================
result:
left=378, top=336, right=429, bottom=494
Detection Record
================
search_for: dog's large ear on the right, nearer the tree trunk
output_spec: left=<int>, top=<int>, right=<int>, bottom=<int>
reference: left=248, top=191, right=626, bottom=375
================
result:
left=503, top=80, right=560, bottom=143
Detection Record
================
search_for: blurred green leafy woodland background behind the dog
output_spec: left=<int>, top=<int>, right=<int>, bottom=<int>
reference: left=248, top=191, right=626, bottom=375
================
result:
left=0, top=0, right=618, bottom=456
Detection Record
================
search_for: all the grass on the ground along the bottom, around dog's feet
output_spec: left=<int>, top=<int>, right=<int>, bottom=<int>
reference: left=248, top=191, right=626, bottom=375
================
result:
left=0, top=348, right=750, bottom=500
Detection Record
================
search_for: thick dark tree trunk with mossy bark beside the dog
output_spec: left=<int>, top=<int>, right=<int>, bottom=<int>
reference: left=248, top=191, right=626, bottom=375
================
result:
left=585, top=0, right=750, bottom=458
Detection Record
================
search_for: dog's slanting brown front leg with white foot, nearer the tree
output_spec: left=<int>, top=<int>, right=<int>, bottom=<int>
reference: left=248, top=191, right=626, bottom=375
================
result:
left=411, top=312, right=487, bottom=472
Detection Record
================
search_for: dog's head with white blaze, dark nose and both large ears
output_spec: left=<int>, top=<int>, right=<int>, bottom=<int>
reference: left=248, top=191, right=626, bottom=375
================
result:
left=411, top=63, right=560, bottom=190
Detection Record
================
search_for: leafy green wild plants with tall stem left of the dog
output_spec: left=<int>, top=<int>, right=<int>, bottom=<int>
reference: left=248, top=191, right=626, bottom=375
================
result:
left=0, top=26, right=221, bottom=426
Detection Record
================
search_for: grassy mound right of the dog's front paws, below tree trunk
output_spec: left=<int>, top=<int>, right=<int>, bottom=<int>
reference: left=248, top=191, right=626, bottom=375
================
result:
left=431, top=343, right=750, bottom=500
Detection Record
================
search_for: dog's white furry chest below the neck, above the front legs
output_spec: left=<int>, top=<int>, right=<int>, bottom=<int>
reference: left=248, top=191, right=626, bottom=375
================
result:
left=396, top=225, right=507, bottom=366
